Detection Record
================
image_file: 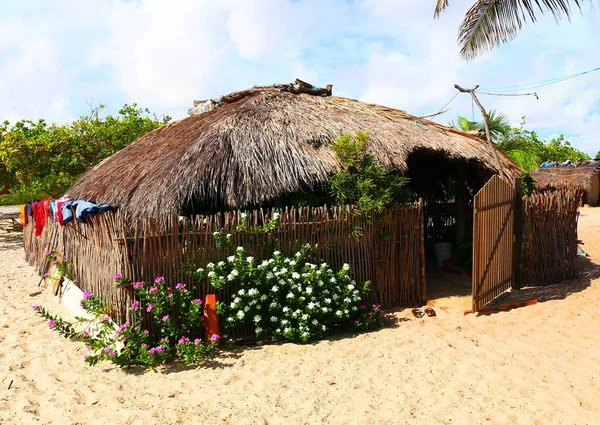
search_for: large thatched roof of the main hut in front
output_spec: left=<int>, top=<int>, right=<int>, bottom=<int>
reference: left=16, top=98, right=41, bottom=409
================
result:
left=68, top=87, right=518, bottom=216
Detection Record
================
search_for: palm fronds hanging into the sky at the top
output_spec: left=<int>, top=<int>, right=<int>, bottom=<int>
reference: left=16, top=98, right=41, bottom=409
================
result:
left=434, top=0, right=584, bottom=59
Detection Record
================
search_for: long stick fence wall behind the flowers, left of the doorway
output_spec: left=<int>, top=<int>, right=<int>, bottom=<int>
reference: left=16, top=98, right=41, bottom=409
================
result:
left=25, top=204, right=425, bottom=320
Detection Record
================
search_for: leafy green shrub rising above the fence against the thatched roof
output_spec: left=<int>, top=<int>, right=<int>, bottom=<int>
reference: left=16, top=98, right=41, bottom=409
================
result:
left=329, top=132, right=410, bottom=217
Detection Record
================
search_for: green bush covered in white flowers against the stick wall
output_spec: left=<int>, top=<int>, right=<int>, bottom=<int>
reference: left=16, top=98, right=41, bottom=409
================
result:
left=204, top=245, right=383, bottom=342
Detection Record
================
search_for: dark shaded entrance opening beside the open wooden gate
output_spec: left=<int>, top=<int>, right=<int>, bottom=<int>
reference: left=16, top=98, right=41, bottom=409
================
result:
left=405, top=149, right=492, bottom=299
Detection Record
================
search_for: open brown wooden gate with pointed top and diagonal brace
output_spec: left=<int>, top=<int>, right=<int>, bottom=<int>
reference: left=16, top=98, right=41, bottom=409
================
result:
left=473, top=175, right=516, bottom=313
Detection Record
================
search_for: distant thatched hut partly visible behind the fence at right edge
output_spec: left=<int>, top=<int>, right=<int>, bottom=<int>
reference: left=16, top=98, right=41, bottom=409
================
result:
left=532, top=161, right=600, bottom=206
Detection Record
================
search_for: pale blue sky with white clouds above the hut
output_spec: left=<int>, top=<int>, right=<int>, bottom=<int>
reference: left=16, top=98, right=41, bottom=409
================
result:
left=0, top=0, right=600, bottom=155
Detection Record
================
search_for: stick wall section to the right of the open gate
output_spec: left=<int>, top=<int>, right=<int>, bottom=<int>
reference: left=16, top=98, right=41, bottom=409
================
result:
left=520, top=187, right=584, bottom=286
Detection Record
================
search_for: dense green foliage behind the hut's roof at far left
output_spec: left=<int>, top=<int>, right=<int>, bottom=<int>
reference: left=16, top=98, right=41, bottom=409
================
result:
left=0, top=104, right=170, bottom=196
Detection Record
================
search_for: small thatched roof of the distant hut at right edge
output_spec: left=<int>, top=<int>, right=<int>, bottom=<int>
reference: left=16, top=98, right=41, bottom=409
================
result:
left=531, top=161, right=600, bottom=191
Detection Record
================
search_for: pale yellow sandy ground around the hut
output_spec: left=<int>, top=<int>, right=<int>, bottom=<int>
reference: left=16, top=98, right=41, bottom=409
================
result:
left=0, top=208, right=600, bottom=425
